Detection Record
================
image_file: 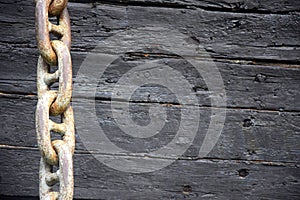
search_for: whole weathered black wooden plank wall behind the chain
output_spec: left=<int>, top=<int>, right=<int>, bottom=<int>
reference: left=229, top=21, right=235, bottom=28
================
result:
left=0, top=0, right=300, bottom=200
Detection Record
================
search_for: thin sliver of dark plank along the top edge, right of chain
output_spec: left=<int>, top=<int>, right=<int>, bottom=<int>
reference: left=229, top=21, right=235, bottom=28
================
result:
left=71, top=0, right=300, bottom=13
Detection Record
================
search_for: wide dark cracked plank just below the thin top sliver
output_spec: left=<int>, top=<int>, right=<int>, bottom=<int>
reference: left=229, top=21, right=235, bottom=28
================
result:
left=0, top=1, right=300, bottom=63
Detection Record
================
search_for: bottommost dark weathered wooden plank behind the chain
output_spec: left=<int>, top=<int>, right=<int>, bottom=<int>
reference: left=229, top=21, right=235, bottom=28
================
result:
left=0, top=148, right=300, bottom=200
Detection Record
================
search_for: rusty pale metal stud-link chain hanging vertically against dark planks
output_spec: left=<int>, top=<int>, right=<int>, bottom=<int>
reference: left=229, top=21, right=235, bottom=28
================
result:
left=35, top=0, right=75, bottom=200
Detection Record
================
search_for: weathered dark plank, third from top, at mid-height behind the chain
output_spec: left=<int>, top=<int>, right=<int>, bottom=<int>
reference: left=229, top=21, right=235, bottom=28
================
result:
left=0, top=48, right=300, bottom=111
